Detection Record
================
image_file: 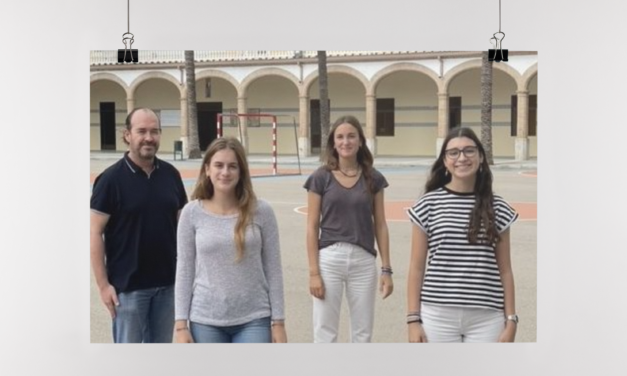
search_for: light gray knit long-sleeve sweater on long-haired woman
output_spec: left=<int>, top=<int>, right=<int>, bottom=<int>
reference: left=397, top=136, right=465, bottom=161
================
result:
left=175, top=200, right=285, bottom=326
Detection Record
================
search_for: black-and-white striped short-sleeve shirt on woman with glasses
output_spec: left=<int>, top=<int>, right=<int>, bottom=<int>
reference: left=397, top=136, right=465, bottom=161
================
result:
left=407, top=187, right=518, bottom=310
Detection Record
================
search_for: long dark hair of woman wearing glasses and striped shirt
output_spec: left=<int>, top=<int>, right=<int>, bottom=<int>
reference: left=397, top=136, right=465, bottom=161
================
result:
left=425, top=127, right=500, bottom=244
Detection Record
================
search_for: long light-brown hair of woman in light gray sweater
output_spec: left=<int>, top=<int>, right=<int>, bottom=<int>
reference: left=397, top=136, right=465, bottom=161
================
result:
left=191, top=137, right=257, bottom=261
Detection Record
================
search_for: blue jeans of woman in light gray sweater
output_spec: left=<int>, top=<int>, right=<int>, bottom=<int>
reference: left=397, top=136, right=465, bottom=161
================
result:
left=189, top=317, right=272, bottom=343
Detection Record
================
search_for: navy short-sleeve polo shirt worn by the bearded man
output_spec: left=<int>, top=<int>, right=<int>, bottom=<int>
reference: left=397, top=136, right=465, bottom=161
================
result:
left=91, top=152, right=187, bottom=292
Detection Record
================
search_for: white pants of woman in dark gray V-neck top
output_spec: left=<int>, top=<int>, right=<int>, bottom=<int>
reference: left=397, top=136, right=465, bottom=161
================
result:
left=313, top=243, right=377, bottom=343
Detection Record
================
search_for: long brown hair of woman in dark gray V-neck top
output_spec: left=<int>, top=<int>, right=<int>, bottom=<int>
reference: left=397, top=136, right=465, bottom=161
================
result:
left=324, top=115, right=375, bottom=194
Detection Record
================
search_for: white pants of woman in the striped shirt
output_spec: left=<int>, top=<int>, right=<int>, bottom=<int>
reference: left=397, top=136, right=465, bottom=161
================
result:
left=420, top=303, right=505, bottom=342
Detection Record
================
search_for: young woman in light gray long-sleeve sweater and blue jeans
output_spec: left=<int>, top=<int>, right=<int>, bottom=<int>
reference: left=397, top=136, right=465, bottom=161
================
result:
left=175, top=137, right=287, bottom=343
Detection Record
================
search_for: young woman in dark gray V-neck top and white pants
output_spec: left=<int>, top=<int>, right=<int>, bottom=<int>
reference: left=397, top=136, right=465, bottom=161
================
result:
left=304, top=116, right=393, bottom=342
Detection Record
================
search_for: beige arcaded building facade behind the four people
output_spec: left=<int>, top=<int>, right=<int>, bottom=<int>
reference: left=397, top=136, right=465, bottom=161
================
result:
left=90, top=51, right=538, bottom=160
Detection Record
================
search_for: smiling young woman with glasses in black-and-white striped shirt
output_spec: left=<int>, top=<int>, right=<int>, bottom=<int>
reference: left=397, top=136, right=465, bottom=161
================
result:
left=407, top=127, right=518, bottom=342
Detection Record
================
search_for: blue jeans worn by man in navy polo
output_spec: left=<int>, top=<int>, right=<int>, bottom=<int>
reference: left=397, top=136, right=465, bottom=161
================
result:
left=113, top=286, right=174, bottom=343
